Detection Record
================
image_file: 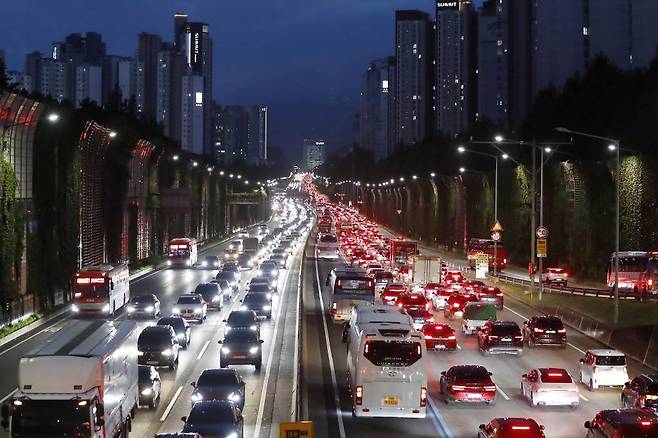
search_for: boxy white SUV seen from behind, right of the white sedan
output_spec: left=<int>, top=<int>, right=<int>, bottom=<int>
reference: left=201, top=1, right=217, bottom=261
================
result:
left=580, top=349, right=629, bottom=391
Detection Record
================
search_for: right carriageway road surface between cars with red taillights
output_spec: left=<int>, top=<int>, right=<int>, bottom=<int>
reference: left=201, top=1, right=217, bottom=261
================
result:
left=302, top=222, right=651, bottom=438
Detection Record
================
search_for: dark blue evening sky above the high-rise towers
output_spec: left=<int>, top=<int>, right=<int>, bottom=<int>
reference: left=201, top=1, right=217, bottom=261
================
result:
left=0, top=0, right=482, bottom=161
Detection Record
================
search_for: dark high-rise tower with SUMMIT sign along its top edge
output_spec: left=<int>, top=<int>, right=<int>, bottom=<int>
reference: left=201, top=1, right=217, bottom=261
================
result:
left=435, top=0, right=477, bottom=135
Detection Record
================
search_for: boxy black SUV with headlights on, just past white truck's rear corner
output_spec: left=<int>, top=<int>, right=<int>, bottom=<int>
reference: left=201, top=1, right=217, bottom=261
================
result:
left=137, top=325, right=179, bottom=370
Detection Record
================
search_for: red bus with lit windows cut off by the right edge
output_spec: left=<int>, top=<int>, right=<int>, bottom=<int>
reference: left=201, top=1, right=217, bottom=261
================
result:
left=607, top=251, right=658, bottom=295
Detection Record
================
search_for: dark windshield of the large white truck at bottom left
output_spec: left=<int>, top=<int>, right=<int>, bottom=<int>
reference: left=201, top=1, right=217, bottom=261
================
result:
left=11, top=400, right=91, bottom=437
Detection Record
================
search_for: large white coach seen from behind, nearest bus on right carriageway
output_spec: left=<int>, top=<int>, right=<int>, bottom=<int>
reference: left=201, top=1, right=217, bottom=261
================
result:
left=346, top=306, right=428, bottom=418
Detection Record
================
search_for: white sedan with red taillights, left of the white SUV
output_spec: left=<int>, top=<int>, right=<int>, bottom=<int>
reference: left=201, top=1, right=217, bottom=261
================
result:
left=521, top=368, right=580, bottom=408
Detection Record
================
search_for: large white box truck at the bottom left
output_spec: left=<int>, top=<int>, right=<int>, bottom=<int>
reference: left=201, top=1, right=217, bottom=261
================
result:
left=2, top=320, right=138, bottom=438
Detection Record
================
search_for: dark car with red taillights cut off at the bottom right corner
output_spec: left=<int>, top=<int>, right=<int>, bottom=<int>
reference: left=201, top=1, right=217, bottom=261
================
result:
left=585, top=409, right=658, bottom=438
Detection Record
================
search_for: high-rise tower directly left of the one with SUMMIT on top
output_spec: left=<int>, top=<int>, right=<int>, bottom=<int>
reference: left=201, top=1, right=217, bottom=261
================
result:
left=395, top=10, right=434, bottom=145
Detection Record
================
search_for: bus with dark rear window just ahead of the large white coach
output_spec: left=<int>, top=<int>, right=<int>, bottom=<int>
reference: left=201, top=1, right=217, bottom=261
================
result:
left=326, top=266, right=375, bottom=322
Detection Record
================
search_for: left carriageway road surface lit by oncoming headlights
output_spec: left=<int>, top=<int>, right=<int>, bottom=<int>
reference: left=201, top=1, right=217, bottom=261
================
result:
left=0, top=219, right=305, bottom=437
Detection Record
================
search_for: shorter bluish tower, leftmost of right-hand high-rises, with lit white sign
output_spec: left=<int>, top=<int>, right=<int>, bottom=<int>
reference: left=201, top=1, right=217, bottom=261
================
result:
left=359, top=58, right=392, bottom=160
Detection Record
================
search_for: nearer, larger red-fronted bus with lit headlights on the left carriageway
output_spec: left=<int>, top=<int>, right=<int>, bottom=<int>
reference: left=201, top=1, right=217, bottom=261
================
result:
left=71, top=264, right=130, bottom=315
